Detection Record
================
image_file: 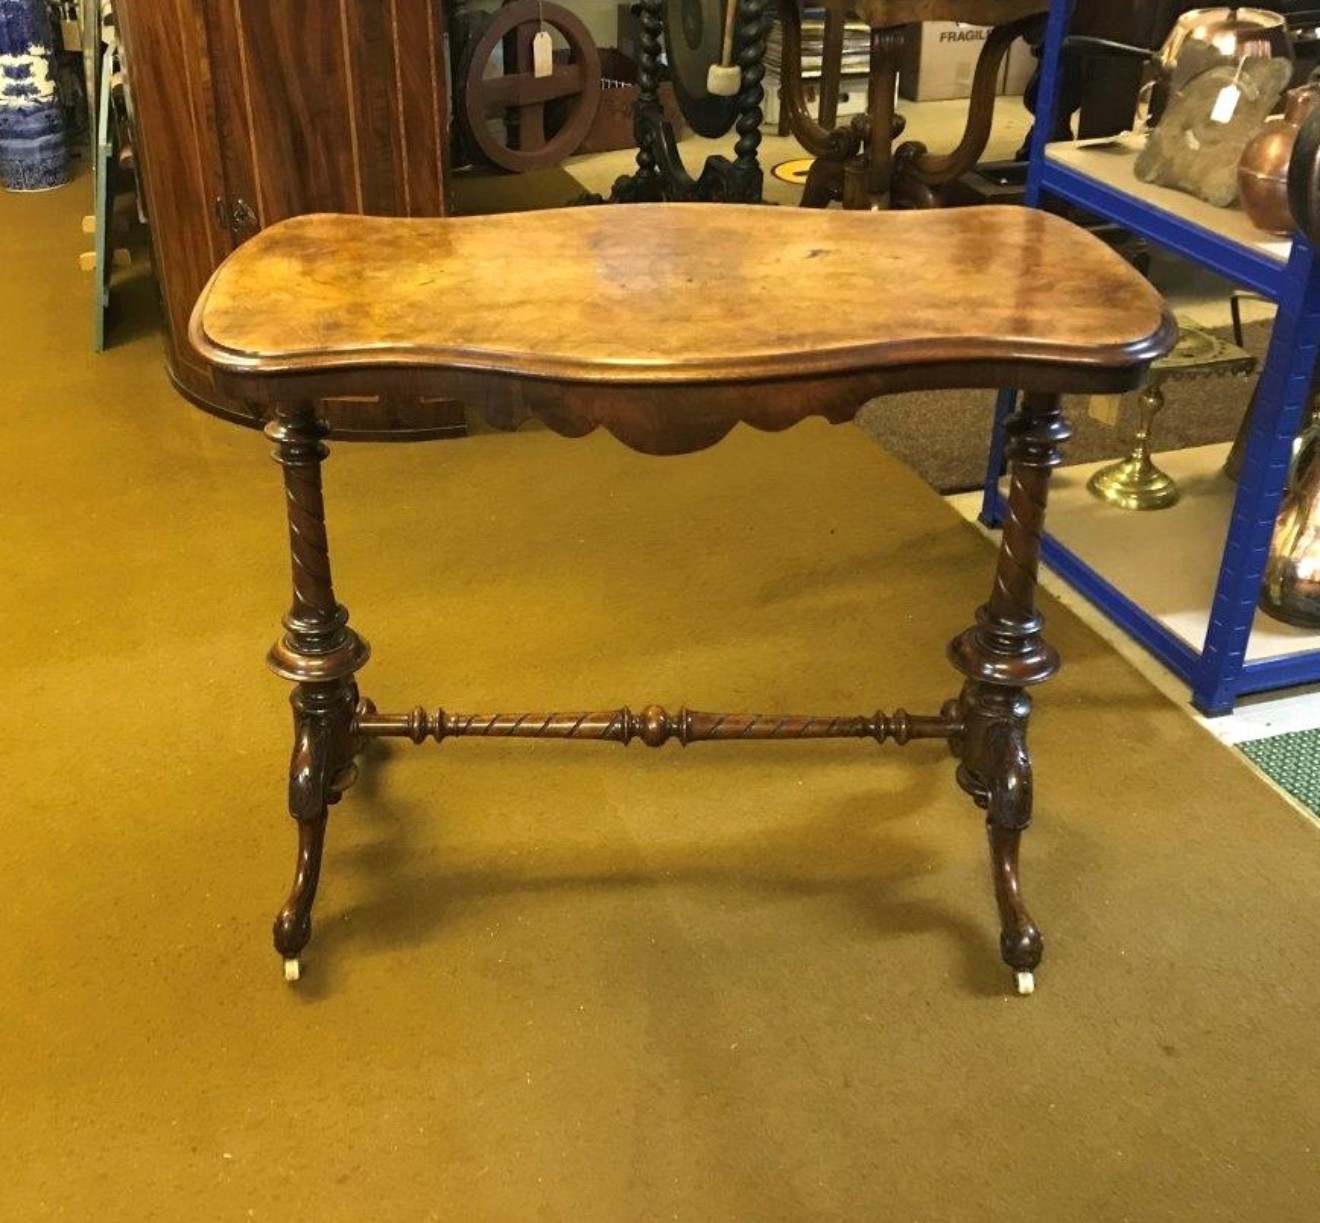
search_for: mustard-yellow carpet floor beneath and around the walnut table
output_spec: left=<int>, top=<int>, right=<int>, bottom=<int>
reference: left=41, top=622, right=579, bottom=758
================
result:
left=0, top=176, right=1320, bottom=1223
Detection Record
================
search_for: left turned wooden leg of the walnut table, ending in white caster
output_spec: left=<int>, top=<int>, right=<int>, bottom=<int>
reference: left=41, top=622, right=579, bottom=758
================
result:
left=265, top=402, right=371, bottom=979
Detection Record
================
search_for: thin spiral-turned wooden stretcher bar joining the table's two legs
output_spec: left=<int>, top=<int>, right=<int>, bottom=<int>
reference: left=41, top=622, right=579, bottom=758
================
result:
left=354, top=703, right=962, bottom=747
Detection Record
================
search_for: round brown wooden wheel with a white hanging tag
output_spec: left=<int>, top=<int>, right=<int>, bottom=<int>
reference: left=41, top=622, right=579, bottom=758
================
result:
left=461, top=0, right=601, bottom=172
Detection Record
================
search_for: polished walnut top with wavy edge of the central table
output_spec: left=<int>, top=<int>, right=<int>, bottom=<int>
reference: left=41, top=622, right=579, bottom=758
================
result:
left=191, top=204, right=1170, bottom=389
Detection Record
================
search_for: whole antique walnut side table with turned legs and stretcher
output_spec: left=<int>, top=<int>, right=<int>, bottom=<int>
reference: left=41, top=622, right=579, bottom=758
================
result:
left=190, top=204, right=1176, bottom=993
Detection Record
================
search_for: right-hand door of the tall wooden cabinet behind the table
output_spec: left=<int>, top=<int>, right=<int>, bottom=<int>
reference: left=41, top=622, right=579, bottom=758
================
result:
left=206, top=0, right=447, bottom=239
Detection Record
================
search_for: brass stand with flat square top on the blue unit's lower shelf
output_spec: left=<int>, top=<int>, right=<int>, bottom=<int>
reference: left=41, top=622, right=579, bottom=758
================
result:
left=1086, top=326, right=1255, bottom=509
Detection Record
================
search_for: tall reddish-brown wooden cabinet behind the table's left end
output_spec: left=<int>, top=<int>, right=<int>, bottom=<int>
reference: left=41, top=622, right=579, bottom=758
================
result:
left=115, top=0, right=463, bottom=438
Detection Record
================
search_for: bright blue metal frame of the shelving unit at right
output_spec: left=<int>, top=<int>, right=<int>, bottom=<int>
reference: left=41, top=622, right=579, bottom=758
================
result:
left=981, top=0, right=1320, bottom=714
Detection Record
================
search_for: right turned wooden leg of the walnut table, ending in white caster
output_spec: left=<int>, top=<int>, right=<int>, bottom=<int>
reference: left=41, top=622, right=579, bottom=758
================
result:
left=949, top=394, right=1071, bottom=993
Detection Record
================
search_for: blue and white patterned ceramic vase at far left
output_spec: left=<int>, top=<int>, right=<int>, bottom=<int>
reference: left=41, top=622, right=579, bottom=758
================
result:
left=0, top=0, right=69, bottom=191
